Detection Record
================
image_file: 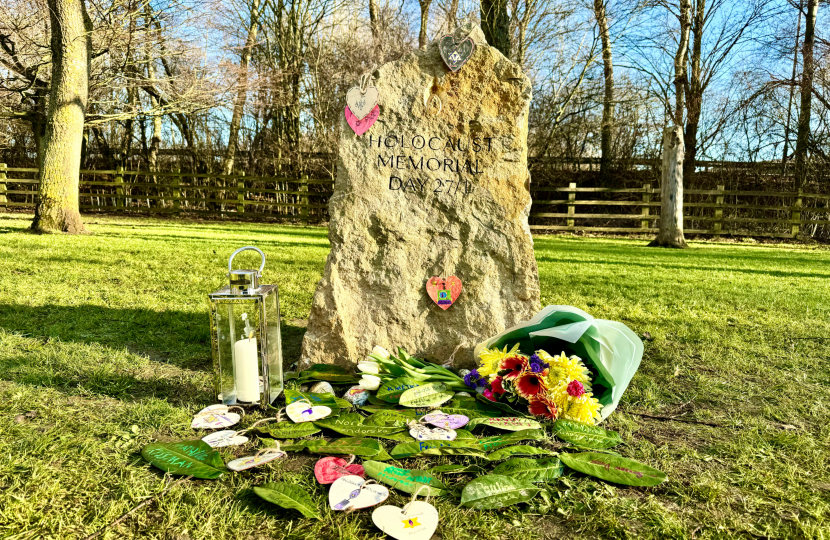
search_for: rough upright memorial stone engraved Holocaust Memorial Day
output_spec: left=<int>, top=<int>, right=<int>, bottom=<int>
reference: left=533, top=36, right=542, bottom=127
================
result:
left=299, top=26, right=540, bottom=370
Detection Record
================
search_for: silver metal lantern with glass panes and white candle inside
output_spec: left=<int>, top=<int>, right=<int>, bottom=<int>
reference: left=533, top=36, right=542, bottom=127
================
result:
left=208, top=246, right=283, bottom=407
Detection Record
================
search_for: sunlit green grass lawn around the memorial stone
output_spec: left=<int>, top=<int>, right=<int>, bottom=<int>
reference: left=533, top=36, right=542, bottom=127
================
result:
left=0, top=214, right=830, bottom=540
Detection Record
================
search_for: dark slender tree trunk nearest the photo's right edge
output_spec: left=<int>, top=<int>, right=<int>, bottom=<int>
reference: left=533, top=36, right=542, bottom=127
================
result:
left=795, top=0, right=819, bottom=189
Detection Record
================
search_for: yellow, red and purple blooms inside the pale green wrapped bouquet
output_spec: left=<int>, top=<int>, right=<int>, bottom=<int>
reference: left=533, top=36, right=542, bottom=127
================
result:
left=464, top=343, right=602, bottom=425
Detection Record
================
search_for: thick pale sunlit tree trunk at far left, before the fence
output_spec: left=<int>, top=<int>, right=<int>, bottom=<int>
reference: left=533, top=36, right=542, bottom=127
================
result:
left=32, top=0, right=92, bottom=233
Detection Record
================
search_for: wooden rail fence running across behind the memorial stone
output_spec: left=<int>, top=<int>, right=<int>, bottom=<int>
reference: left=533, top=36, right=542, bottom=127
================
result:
left=0, top=164, right=830, bottom=238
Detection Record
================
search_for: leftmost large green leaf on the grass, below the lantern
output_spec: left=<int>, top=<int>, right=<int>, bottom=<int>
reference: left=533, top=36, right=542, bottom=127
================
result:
left=141, top=440, right=227, bottom=480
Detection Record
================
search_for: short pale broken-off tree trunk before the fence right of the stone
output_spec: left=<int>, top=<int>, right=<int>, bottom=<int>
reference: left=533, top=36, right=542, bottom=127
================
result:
left=649, top=126, right=688, bottom=248
